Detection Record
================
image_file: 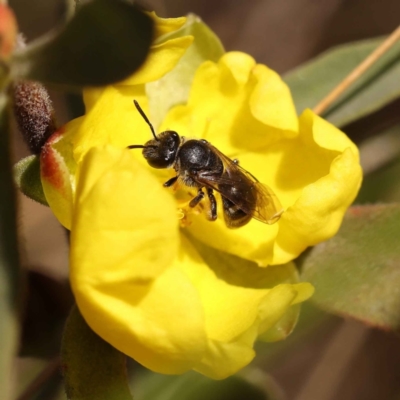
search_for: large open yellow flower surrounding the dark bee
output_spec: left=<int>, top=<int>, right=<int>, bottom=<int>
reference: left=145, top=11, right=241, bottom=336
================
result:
left=42, top=23, right=361, bottom=379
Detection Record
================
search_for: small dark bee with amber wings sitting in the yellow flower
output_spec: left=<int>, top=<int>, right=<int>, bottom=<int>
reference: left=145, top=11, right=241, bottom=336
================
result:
left=128, top=100, right=283, bottom=228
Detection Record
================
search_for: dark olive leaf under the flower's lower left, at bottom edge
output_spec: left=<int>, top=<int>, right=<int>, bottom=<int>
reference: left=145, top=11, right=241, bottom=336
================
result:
left=61, top=306, right=132, bottom=400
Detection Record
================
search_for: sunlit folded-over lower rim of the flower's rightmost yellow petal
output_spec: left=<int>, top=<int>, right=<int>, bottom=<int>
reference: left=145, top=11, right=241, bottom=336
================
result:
left=273, top=148, right=362, bottom=263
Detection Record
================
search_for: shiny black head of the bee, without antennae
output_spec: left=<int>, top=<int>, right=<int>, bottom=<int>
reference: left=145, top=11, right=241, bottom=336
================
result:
left=143, top=131, right=181, bottom=168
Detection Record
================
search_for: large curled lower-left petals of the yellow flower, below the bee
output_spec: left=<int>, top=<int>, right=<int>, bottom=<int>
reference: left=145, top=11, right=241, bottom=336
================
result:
left=70, top=147, right=313, bottom=379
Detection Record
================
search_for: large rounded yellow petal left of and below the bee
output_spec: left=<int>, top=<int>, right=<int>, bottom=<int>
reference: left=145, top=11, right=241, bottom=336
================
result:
left=71, top=148, right=209, bottom=373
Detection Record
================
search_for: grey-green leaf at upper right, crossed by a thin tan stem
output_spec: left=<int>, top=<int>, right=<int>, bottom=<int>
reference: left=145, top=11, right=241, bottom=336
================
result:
left=284, top=38, right=400, bottom=126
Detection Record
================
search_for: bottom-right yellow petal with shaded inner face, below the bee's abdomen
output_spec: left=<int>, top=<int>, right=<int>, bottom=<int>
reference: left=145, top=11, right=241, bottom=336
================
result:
left=180, top=241, right=312, bottom=379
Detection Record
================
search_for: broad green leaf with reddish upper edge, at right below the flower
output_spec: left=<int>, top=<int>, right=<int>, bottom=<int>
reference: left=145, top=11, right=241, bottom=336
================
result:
left=301, top=204, right=400, bottom=331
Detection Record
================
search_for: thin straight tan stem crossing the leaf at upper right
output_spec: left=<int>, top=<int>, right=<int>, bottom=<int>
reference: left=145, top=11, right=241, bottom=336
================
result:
left=313, top=26, right=400, bottom=115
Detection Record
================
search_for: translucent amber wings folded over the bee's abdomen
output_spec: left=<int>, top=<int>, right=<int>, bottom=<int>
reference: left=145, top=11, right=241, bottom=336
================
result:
left=198, top=144, right=283, bottom=225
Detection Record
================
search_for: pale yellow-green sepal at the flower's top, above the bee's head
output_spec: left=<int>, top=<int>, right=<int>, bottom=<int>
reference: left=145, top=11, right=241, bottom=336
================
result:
left=146, top=14, right=225, bottom=127
